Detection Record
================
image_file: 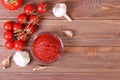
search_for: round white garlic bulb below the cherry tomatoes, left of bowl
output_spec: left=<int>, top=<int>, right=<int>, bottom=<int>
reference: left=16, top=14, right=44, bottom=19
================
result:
left=13, top=51, right=30, bottom=67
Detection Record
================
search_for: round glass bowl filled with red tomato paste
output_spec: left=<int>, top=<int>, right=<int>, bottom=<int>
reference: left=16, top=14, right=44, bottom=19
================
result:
left=32, top=33, right=63, bottom=62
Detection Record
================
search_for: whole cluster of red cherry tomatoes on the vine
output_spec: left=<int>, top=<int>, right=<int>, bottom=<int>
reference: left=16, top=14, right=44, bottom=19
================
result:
left=3, top=2, right=48, bottom=50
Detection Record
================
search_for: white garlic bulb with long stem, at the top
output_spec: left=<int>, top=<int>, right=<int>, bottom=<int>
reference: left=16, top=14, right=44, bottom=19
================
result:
left=53, top=3, right=72, bottom=21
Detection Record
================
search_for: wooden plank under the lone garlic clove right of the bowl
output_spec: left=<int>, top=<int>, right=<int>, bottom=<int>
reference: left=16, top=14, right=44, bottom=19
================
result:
left=0, top=20, right=120, bottom=46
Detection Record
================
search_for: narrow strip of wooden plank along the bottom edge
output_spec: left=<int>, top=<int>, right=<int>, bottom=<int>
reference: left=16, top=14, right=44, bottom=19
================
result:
left=0, top=72, right=120, bottom=80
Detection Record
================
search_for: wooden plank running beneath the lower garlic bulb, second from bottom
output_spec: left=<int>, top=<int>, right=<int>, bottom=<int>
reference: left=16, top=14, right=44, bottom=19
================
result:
left=0, top=47, right=120, bottom=73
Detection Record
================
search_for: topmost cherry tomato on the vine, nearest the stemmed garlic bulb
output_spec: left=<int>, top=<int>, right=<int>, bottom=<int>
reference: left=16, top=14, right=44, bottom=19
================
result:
left=37, top=2, right=48, bottom=14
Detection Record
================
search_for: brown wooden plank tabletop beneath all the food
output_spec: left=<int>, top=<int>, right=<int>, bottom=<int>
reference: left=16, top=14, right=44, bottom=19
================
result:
left=0, top=0, right=120, bottom=80
